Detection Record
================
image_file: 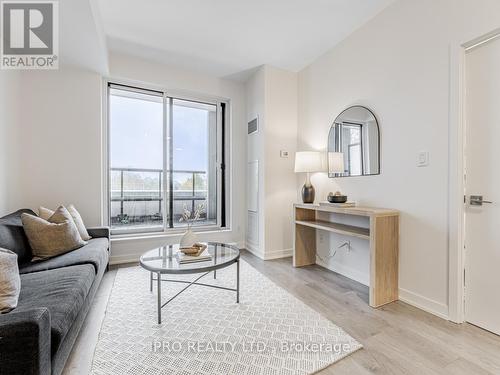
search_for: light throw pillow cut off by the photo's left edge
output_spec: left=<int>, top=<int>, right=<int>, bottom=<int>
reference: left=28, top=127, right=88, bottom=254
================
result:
left=0, top=248, right=21, bottom=314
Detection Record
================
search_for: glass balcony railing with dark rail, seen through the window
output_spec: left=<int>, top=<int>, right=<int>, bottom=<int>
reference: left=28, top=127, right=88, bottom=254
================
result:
left=111, top=168, right=207, bottom=227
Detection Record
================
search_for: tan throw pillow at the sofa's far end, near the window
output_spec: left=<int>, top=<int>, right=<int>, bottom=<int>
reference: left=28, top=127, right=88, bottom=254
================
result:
left=21, top=213, right=85, bottom=259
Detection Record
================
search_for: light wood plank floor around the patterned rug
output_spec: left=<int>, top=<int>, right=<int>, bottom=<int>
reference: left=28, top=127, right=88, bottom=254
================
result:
left=64, top=252, right=500, bottom=375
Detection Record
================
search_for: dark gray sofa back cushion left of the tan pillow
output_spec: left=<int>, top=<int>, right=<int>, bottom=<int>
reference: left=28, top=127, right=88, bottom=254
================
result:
left=0, top=209, right=35, bottom=264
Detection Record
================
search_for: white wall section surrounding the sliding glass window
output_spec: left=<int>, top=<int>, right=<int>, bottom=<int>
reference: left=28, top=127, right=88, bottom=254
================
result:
left=109, top=53, right=247, bottom=262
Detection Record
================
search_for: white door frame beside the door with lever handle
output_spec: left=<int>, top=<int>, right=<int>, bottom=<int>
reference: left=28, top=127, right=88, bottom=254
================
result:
left=448, top=28, right=500, bottom=323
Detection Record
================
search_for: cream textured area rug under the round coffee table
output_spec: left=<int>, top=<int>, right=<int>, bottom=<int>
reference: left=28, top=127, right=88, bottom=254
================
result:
left=91, top=261, right=362, bottom=375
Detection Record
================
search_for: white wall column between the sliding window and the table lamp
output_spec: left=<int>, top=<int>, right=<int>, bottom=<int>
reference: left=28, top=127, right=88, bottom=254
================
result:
left=246, top=65, right=298, bottom=259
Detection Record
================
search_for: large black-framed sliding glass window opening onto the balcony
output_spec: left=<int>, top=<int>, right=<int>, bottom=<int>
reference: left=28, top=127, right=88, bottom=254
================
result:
left=108, top=83, right=227, bottom=234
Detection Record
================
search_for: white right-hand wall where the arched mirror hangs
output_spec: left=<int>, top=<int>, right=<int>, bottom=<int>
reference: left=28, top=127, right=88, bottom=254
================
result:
left=297, top=0, right=500, bottom=316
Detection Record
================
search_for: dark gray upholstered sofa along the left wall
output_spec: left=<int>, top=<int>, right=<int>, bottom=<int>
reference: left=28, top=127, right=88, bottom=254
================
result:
left=0, top=210, right=109, bottom=375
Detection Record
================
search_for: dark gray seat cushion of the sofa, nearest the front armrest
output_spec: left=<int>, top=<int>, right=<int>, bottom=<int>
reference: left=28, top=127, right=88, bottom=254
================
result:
left=15, top=264, right=96, bottom=355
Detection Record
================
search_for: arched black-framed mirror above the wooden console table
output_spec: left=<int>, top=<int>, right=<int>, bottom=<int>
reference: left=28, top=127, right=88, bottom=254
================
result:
left=328, top=106, right=380, bottom=177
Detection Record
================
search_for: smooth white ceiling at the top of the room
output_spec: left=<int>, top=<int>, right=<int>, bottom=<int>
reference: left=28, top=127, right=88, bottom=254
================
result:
left=98, top=0, right=393, bottom=77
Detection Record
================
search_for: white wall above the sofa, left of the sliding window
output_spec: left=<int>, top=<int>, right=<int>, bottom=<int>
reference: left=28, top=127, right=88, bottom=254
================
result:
left=0, top=68, right=101, bottom=225
